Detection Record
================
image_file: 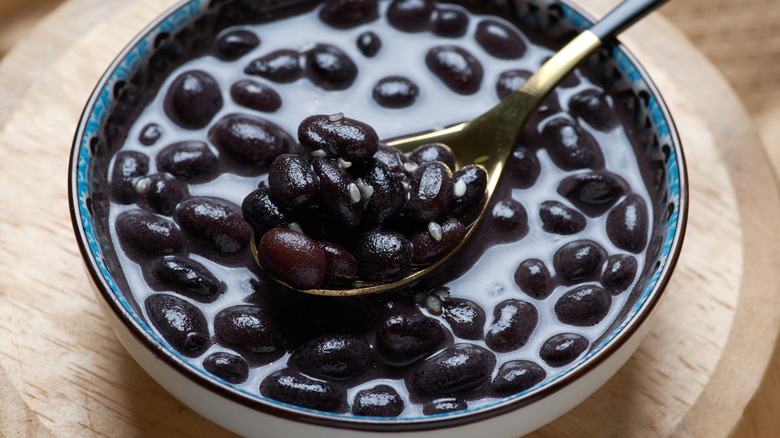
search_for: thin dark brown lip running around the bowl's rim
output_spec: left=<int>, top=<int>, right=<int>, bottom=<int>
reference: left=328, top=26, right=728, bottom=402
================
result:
left=68, top=0, right=688, bottom=432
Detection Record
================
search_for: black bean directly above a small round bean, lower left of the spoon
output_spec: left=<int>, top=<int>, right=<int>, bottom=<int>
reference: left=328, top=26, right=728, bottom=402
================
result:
left=214, top=305, right=284, bottom=353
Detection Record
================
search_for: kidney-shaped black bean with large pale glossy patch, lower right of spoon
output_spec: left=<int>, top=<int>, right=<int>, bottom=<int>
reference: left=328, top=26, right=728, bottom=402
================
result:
left=485, top=299, right=539, bottom=353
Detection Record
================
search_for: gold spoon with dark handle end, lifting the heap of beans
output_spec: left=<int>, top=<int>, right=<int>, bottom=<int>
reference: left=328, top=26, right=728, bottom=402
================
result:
left=250, top=0, right=667, bottom=296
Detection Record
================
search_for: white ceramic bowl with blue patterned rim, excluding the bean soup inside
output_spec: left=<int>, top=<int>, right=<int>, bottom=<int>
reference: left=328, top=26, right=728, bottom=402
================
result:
left=69, top=0, right=687, bottom=438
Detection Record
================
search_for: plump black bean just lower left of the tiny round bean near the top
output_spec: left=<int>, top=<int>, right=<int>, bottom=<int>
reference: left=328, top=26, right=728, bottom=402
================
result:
left=304, top=44, right=358, bottom=91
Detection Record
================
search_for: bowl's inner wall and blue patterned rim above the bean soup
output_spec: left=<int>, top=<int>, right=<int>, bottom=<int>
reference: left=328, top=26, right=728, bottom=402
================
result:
left=70, top=0, right=686, bottom=428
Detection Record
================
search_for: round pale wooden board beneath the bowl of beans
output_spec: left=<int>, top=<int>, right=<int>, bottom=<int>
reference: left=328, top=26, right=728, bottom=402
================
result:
left=0, top=0, right=780, bottom=437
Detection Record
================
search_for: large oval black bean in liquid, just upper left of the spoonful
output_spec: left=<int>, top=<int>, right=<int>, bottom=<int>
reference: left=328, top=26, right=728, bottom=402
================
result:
left=208, top=114, right=295, bottom=165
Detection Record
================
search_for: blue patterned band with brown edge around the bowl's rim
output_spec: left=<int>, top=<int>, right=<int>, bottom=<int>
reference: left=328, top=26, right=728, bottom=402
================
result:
left=68, top=0, right=688, bottom=432
